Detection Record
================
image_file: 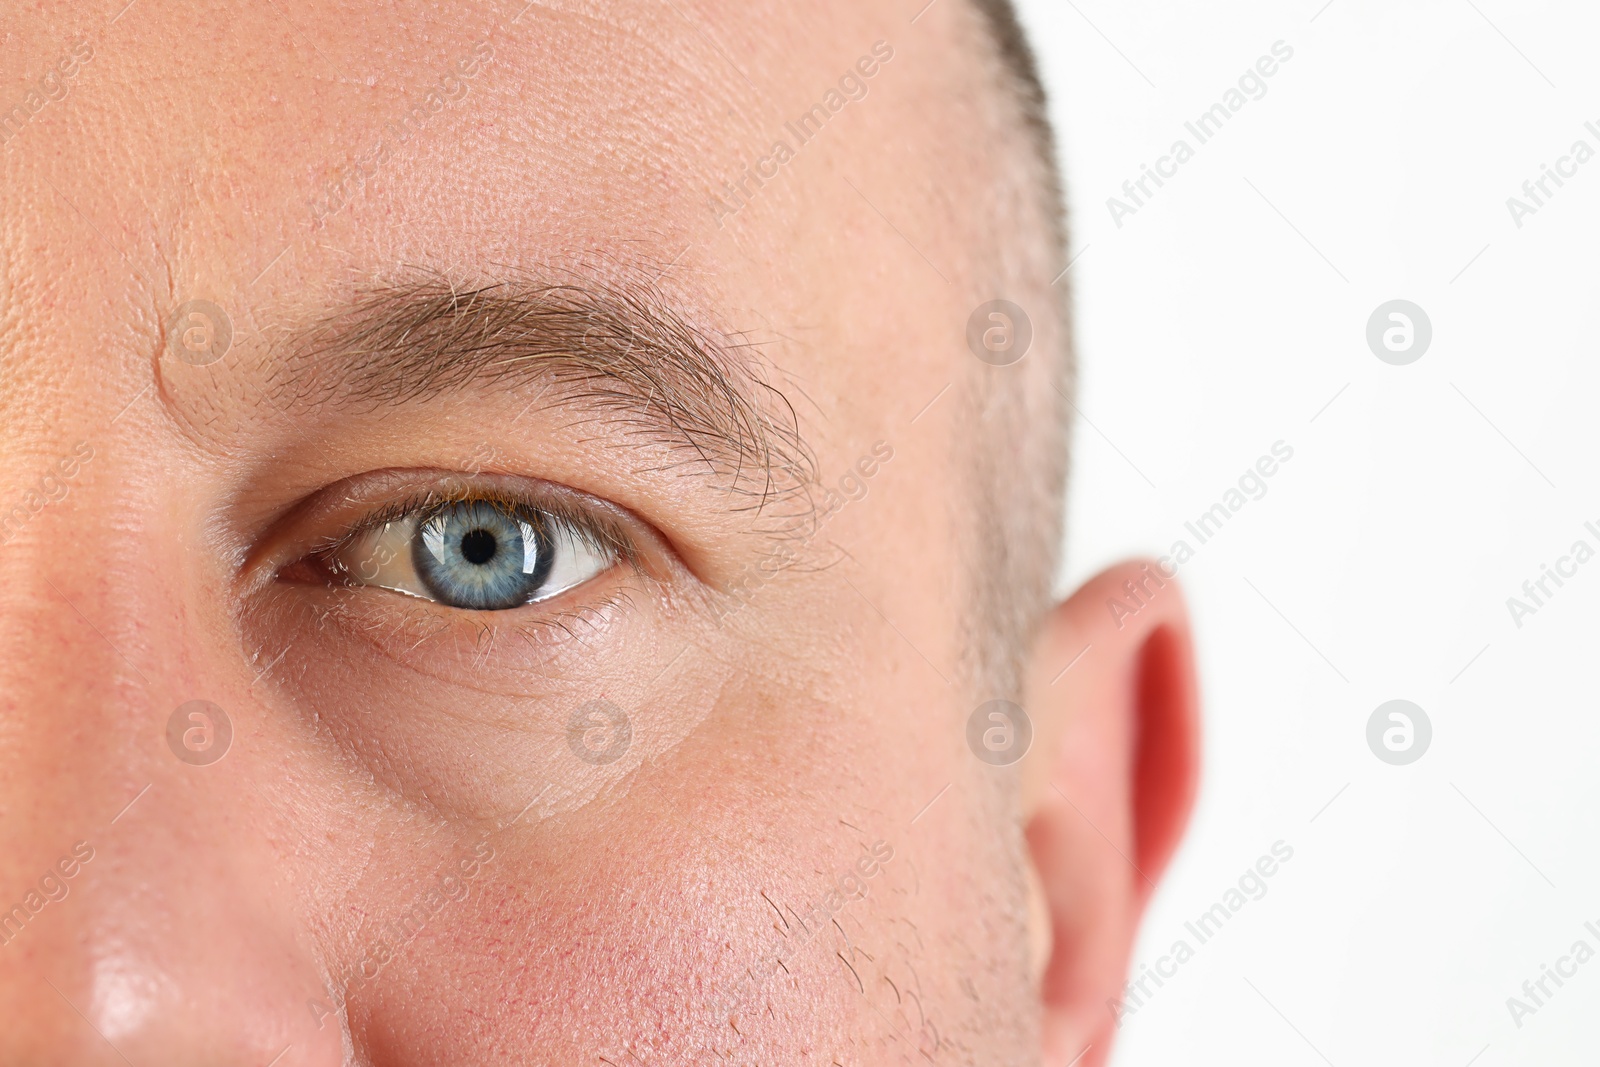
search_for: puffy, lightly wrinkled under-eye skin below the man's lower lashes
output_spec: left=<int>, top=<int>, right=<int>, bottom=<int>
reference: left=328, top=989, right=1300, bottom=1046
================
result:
left=250, top=590, right=720, bottom=821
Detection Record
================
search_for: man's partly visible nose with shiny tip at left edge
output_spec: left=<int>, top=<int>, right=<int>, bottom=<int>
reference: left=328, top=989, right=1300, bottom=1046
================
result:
left=0, top=445, right=342, bottom=1067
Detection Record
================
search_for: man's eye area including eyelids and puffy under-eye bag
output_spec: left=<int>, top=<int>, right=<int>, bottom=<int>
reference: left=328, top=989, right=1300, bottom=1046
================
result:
left=238, top=467, right=681, bottom=817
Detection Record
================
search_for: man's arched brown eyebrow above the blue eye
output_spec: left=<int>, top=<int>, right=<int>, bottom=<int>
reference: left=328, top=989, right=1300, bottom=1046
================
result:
left=269, top=277, right=814, bottom=510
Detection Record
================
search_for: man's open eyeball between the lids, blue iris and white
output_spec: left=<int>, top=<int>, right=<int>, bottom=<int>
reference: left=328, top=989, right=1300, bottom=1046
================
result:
left=306, top=488, right=629, bottom=611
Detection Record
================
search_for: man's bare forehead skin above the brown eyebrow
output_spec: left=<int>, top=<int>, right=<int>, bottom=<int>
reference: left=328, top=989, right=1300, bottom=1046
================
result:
left=0, top=0, right=978, bottom=391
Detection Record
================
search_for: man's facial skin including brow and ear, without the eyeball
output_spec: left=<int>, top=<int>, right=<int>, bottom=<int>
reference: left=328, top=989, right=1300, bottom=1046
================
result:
left=0, top=0, right=1197, bottom=1067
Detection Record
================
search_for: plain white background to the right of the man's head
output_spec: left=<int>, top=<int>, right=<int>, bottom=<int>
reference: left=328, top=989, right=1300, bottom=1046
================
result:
left=1022, top=0, right=1600, bottom=1067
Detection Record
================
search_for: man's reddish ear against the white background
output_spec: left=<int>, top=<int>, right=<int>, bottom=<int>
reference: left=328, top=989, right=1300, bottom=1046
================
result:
left=1022, top=560, right=1200, bottom=1067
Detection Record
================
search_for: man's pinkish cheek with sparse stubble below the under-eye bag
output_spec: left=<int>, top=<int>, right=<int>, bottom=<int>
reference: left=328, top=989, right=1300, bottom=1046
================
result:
left=334, top=694, right=972, bottom=1067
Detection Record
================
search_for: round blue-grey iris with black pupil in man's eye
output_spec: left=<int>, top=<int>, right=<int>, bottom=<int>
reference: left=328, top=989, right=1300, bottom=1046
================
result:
left=411, top=501, right=555, bottom=611
